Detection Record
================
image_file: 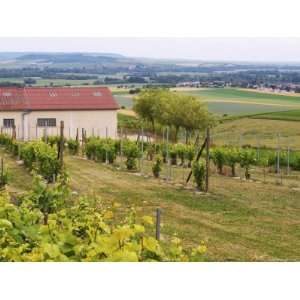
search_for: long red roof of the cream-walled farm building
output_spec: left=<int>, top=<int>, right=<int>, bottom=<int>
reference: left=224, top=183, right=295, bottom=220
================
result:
left=0, top=87, right=119, bottom=111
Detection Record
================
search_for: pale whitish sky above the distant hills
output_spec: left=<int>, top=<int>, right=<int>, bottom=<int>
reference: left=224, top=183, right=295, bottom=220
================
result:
left=0, top=37, right=300, bottom=62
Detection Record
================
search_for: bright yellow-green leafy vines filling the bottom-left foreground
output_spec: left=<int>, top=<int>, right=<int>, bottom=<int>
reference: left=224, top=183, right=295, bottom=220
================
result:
left=0, top=189, right=206, bottom=262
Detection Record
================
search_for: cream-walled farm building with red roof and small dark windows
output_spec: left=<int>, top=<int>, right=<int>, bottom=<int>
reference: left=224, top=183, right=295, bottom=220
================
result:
left=0, top=87, right=119, bottom=140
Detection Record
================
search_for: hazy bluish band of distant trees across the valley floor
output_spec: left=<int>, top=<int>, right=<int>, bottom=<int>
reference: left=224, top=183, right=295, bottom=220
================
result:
left=0, top=64, right=300, bottom=89
